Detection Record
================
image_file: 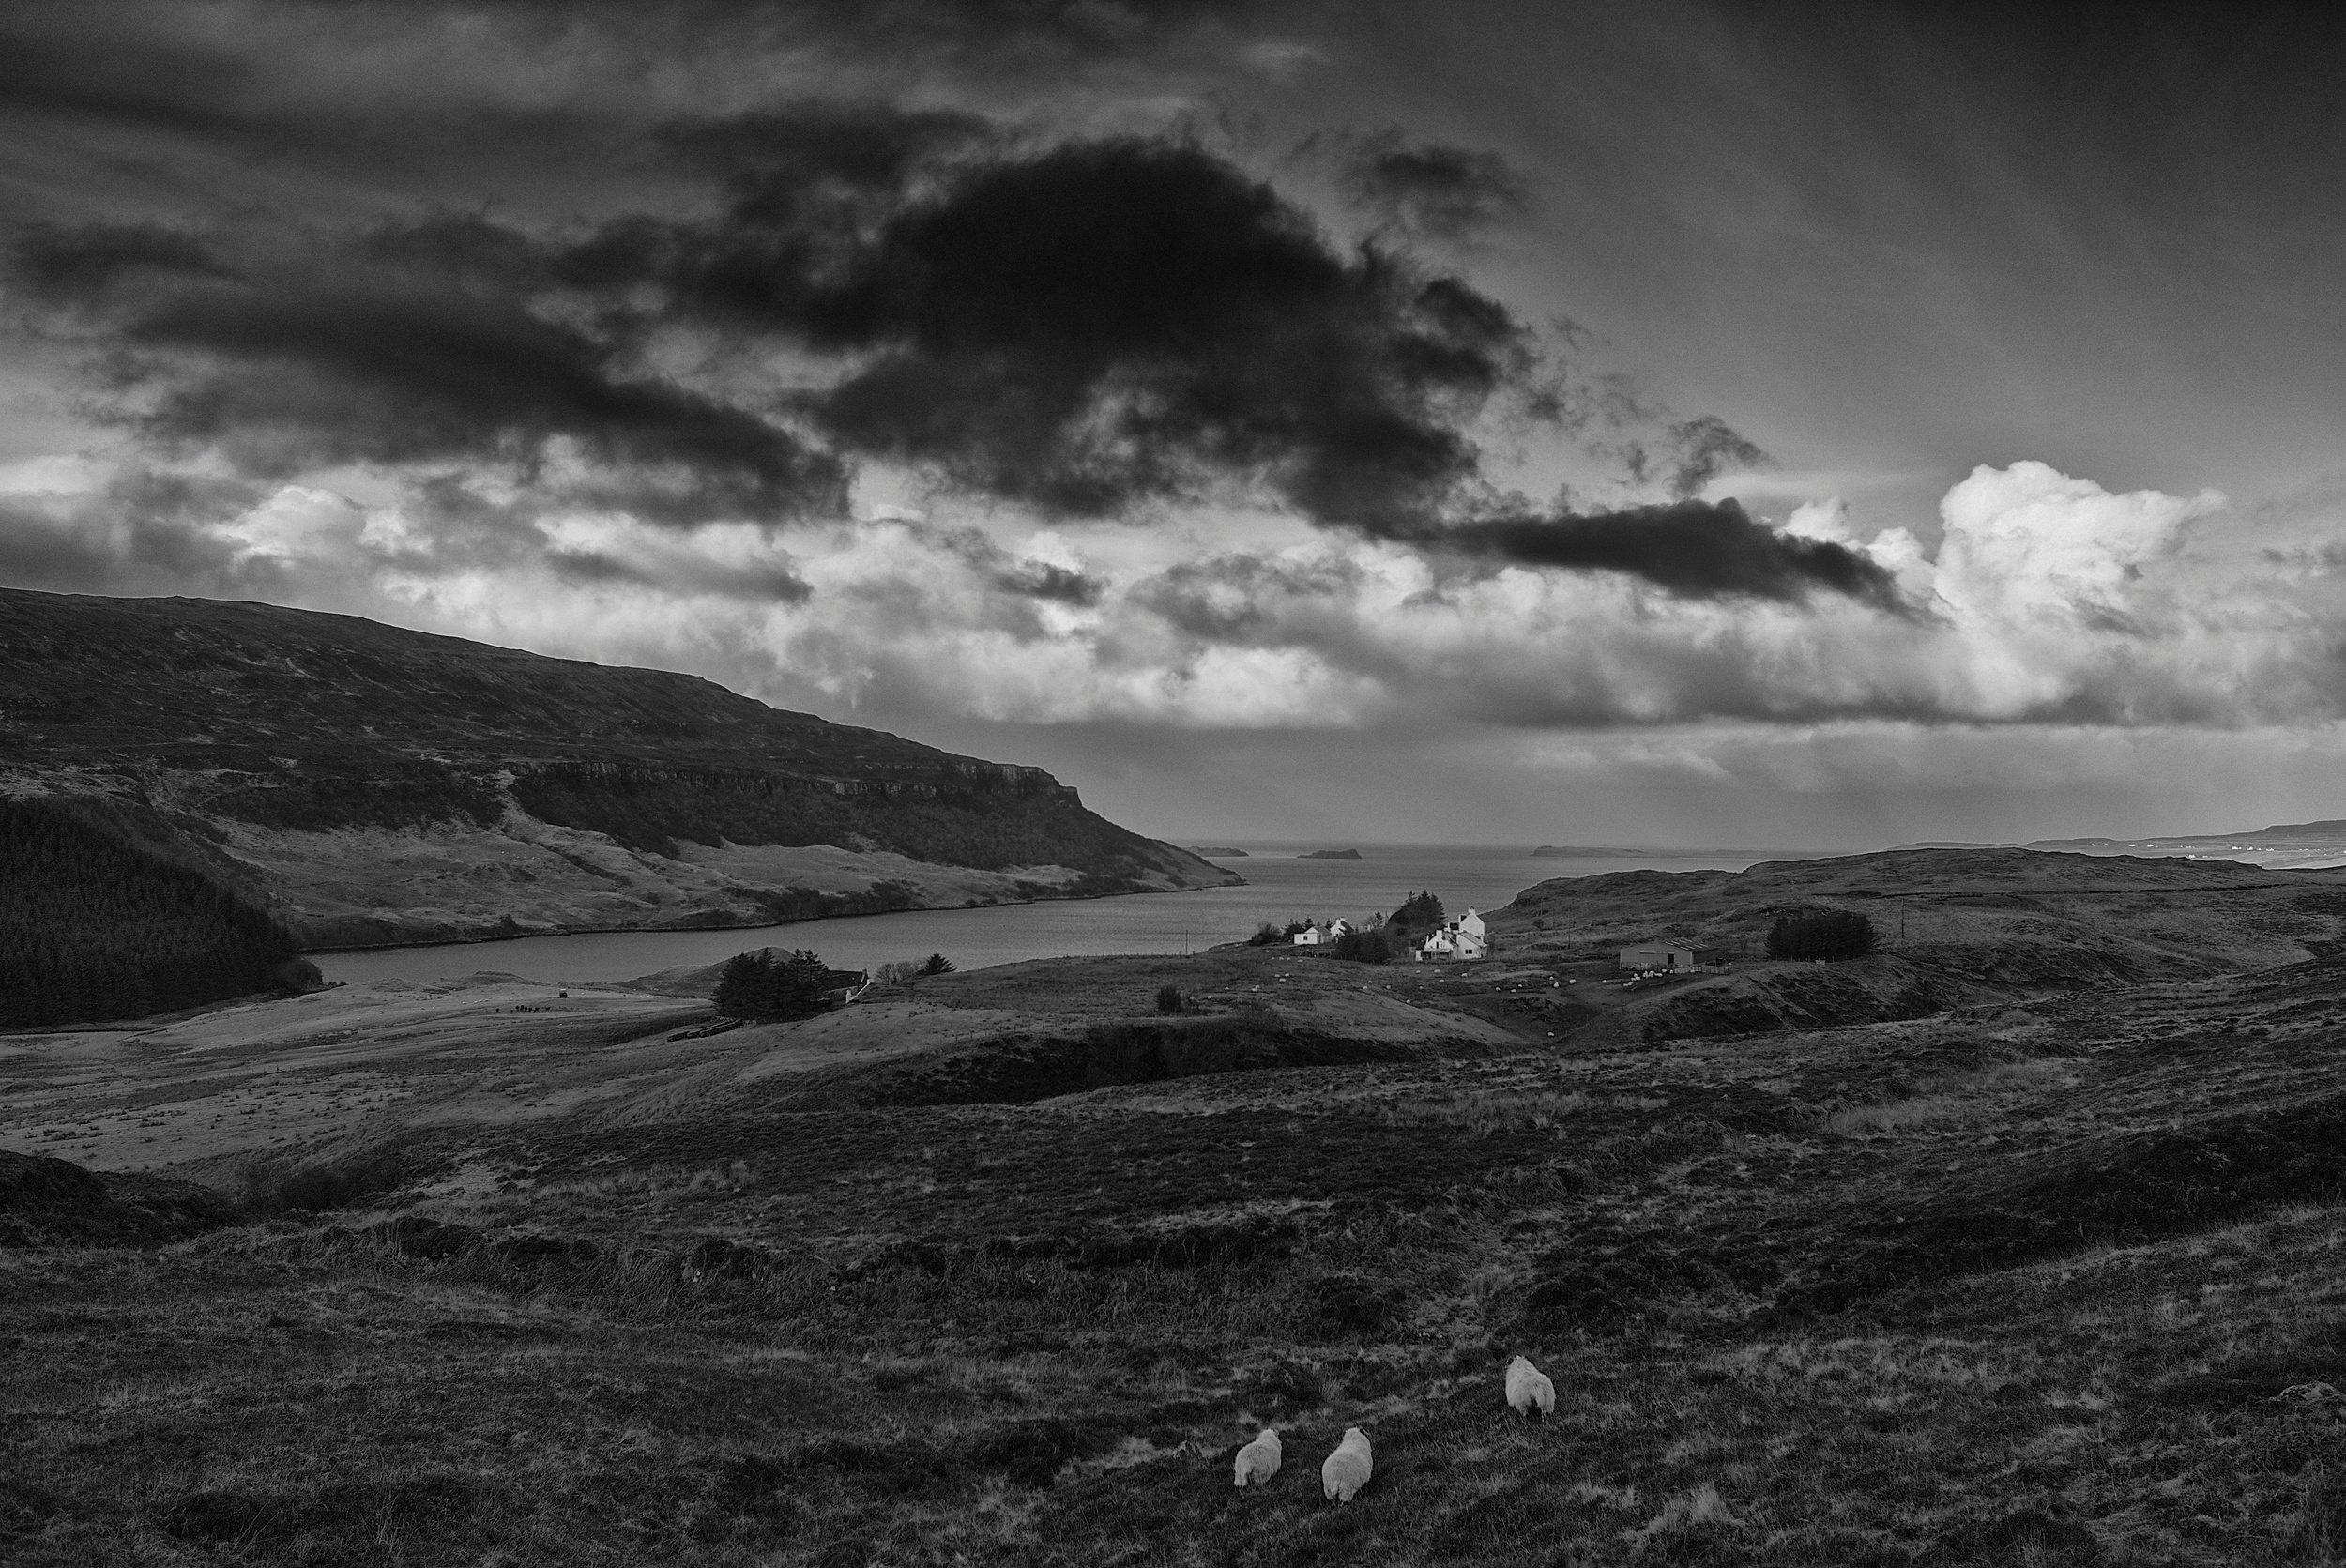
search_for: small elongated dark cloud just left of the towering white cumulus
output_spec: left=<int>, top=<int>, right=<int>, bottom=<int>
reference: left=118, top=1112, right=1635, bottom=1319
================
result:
left=1410, top=500, right=1900, bottom=610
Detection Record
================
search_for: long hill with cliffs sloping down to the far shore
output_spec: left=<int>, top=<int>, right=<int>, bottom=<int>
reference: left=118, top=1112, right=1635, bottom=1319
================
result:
left=0, top=589, right=1237, bottom=949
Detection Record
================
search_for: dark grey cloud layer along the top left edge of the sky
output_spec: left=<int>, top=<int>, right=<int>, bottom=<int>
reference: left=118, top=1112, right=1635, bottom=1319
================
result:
left=0, top=0, right=1286, bottom=174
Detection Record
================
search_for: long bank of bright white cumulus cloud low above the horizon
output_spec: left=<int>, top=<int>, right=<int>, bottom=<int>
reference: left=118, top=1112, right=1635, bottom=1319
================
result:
left=0, top=450, right=2346, bottom=730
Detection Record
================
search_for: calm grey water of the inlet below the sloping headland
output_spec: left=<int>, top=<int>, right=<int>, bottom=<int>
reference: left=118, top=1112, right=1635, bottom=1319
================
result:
left=312, top=841, right=1802, bottom=983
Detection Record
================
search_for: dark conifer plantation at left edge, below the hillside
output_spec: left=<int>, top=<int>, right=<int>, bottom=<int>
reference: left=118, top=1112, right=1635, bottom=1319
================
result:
left=0, top=800, right=314, bottom=1028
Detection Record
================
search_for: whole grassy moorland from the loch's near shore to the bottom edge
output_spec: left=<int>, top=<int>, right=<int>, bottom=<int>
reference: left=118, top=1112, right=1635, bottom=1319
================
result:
left=13, top=857, right=2346, bottom=1565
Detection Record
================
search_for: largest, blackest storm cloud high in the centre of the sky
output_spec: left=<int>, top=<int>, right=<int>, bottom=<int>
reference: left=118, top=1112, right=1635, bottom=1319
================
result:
left=624, top=125, right=1530, bottom=524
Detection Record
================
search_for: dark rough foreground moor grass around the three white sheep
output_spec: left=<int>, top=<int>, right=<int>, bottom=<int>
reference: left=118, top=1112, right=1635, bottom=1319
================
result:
left=13, top=943, right=2346, bottom=1568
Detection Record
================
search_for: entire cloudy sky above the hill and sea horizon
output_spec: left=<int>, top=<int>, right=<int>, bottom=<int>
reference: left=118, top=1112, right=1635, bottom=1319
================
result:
left=0, top=0, right=2346, bottom=850
